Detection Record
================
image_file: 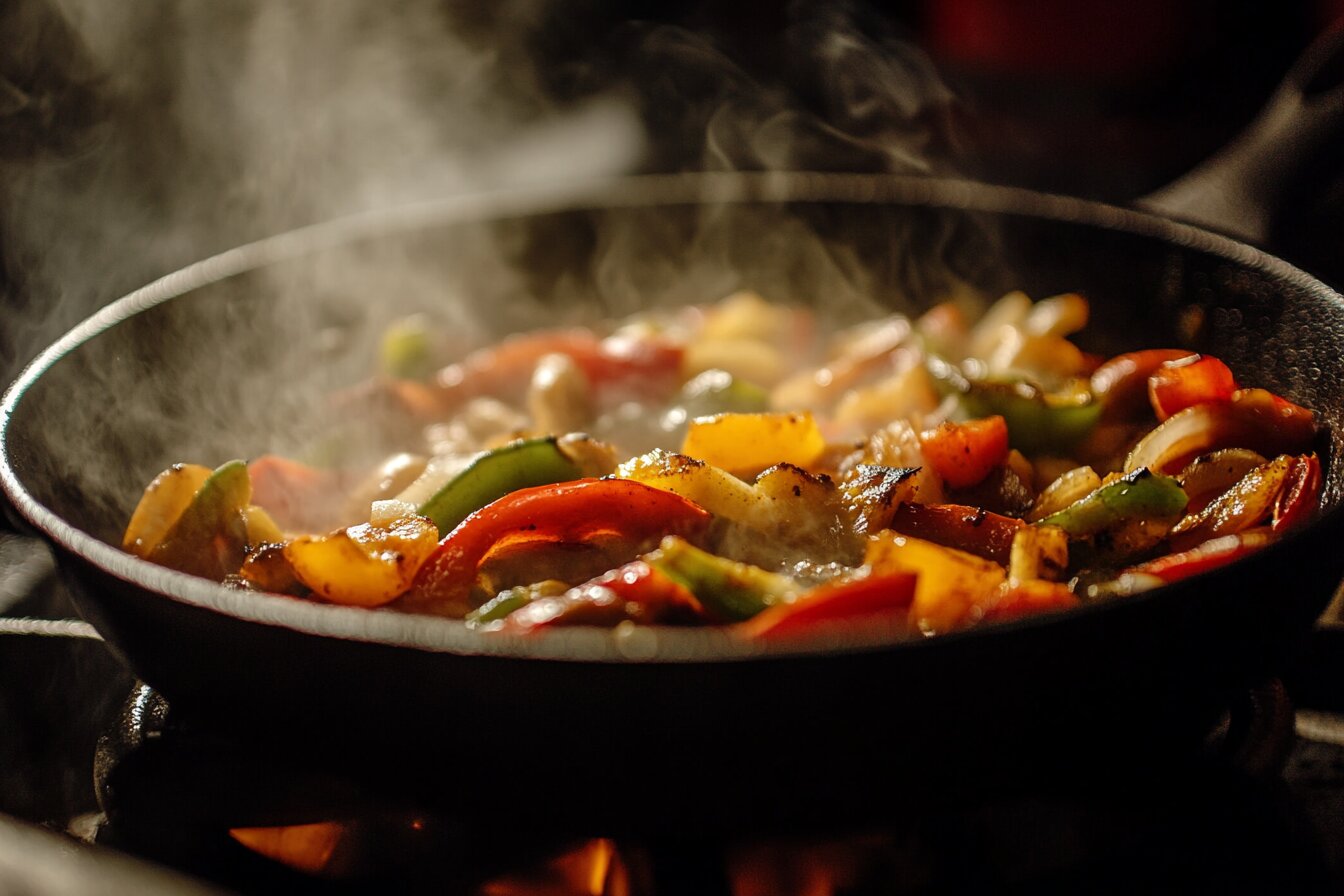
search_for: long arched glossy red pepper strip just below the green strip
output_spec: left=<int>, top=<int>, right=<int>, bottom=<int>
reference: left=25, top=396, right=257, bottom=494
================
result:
left=402, top=480, right=711, bottom=617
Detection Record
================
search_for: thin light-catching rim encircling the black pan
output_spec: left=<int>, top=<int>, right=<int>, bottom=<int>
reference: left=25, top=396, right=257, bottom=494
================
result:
left=0, top=172, right=1344, bottom=664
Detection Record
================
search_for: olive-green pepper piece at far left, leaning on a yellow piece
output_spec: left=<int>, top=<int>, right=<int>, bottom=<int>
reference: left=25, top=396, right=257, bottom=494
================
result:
left=146, top=461, right=251, bottom=582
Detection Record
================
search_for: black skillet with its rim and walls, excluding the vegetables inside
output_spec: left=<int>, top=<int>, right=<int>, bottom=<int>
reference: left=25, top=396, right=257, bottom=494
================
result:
left=0, top=28, right=1344, bottom=832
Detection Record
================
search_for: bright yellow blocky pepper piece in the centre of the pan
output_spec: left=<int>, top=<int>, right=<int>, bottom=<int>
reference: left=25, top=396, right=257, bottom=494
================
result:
left=681, top=411, right=827, bottom=476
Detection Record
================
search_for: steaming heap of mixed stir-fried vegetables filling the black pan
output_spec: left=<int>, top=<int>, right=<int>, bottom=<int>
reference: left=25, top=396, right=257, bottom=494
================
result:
left=122, top=292, right=1322, bottom=641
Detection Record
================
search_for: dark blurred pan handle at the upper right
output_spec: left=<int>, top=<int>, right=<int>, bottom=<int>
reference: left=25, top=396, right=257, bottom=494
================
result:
left=1136, top=23, right=1344, bottom=244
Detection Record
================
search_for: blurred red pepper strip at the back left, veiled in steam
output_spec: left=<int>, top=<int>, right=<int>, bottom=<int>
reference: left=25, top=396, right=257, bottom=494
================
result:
left=435, top=328, right=684, bottom=406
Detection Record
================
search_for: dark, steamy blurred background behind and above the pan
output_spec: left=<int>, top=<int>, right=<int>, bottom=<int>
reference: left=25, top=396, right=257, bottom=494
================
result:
left=0, top=0, right=1344, bottom=382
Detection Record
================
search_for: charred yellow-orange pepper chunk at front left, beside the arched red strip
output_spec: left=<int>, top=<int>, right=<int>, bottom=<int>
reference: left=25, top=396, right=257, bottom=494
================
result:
left=285, top=516, right=438, bottom=607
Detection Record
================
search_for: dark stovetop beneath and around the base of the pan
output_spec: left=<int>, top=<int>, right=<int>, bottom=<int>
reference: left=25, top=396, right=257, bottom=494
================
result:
left=0, top=535, right=1344, bottom=893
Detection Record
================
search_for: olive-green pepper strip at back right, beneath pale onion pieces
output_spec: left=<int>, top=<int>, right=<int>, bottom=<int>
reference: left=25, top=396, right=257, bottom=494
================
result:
left=926, top=356, right=1102, bottom=454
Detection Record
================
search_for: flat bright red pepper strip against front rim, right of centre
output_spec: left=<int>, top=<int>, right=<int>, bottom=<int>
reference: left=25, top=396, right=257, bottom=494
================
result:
left=737, top=572, right=918, bottom=639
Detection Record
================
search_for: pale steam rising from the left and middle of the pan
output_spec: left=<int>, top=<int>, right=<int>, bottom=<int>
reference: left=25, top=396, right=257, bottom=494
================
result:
left=0, top=0, right=978, bottom=537
